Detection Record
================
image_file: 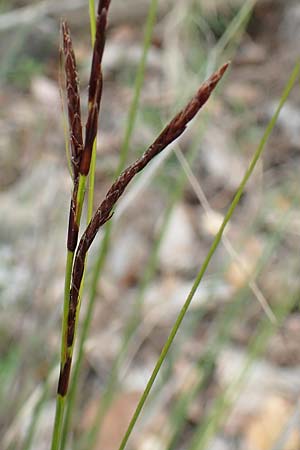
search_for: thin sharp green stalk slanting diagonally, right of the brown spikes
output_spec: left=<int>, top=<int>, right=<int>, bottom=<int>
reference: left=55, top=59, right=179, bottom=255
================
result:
left=115, top=62, right=300, bottom=450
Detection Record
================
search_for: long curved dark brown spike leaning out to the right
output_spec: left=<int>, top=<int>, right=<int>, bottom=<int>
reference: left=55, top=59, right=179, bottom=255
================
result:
left=68, top=63, right=229, bottom=346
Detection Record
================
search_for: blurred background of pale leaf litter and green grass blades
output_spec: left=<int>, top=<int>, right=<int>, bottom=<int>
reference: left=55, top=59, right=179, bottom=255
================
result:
left=0, top=0, right=300, bottom=450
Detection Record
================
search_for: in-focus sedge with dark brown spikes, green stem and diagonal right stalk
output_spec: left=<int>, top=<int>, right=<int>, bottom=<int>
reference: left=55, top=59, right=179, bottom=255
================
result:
left=51, top=0, right=300, bottom=450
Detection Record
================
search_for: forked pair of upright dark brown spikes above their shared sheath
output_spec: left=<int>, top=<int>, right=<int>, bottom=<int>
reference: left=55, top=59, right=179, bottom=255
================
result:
left=62, top=0, right=110, bottom=252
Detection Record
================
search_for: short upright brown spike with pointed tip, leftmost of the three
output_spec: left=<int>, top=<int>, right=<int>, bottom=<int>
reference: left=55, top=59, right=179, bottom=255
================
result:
left=62, top=22, right=83, bottom=179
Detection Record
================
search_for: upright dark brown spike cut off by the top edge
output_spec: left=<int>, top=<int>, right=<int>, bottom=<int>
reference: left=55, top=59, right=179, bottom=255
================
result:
left=80, top=0, right=110, bottom=175
